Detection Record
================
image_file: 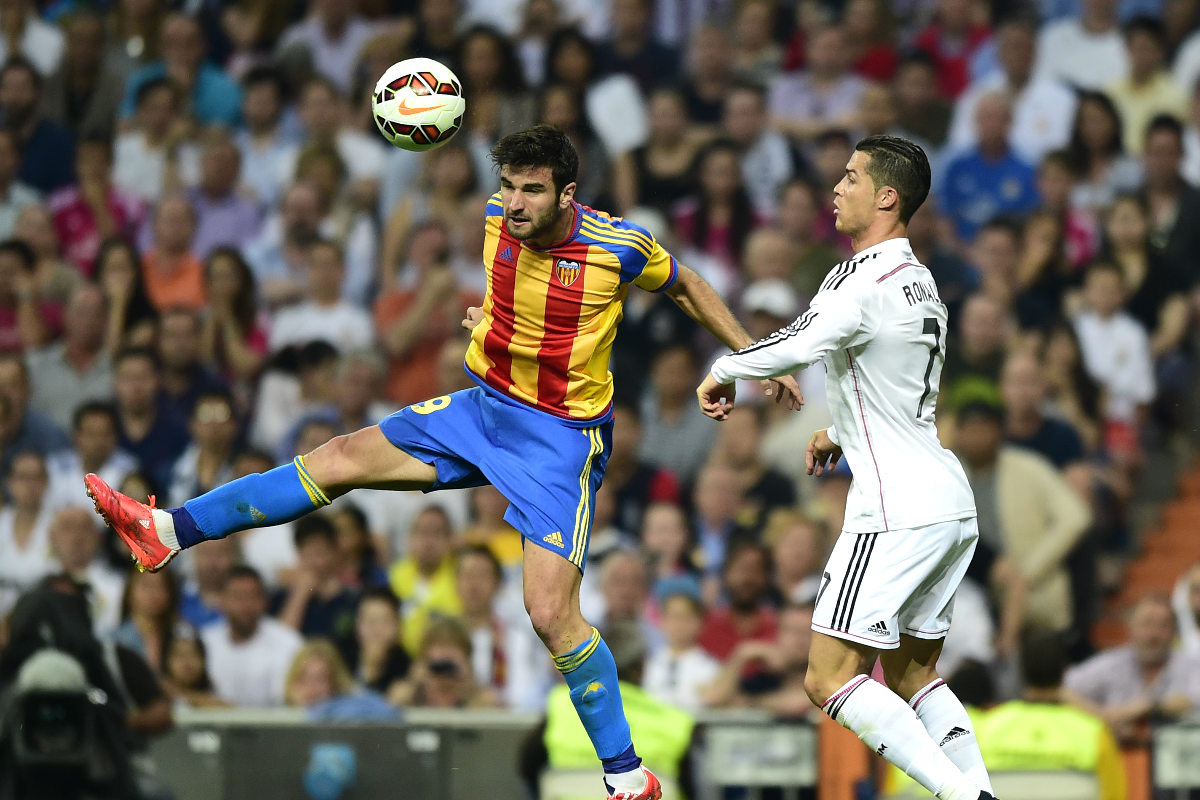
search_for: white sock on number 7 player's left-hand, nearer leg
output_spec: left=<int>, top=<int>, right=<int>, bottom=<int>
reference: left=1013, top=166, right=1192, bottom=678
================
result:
left=822, top=675, right=979, bottom=800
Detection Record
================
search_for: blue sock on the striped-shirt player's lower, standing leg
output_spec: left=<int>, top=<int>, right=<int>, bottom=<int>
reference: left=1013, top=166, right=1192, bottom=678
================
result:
left=554, top=627, right=642, bottom=775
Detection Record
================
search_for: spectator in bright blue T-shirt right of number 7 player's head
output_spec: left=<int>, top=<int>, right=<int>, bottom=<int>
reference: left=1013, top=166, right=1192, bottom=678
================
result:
left=942, top=91, right=1038, bottom=242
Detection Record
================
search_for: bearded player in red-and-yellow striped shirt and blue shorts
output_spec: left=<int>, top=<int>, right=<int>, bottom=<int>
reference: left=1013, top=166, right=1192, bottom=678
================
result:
left=86, top=126, right=802, bottom=800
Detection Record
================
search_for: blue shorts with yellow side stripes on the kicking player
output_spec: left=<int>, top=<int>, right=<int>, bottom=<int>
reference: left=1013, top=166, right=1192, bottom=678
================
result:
left=379, top=386, right=612, bottom=571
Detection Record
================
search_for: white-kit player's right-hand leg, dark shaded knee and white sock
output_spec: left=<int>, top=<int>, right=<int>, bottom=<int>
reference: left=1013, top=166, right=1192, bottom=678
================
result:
left=880, top=633, right=992, bottom=793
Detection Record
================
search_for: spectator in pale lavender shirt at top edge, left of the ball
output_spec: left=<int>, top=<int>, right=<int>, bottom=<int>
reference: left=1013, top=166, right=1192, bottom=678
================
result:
left=276, top=0, right=376, bottom=92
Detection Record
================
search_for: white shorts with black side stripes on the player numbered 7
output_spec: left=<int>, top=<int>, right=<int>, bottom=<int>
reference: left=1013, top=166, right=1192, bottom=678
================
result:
left=812, top=517, right=979, bottom=650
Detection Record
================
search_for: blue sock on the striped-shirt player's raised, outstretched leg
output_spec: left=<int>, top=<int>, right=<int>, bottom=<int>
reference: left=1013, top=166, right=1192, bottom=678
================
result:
left=168, top=456, right=331, bottom=551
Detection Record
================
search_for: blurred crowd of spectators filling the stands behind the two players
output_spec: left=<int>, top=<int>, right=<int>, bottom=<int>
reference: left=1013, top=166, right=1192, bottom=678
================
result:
left=0, top=0, right=1200, bottom=777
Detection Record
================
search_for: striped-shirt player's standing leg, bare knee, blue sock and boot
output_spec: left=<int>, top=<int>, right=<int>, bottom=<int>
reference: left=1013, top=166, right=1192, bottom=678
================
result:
left=523, top=546, right=662, bottom=800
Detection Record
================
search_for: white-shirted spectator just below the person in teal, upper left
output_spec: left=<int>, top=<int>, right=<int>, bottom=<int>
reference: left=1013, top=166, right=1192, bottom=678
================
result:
left=113, top=78, right=200, bottom=204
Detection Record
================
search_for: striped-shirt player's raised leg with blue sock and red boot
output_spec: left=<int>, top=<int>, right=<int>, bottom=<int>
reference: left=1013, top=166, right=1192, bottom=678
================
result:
left=84, top=426, right=437, bottom=571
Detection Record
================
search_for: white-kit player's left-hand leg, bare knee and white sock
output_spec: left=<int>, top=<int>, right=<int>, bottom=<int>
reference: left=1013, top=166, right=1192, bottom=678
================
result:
left=804, top=631, right=989, bottom=800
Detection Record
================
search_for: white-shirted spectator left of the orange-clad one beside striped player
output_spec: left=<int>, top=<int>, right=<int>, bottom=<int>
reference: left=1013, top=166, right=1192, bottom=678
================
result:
left=270, top=240, right=374, bottom=353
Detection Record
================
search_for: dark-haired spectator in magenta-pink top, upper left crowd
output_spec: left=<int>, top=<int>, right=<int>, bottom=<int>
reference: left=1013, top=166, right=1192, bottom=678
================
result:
left=49, top=134, right=145, bottom=276
